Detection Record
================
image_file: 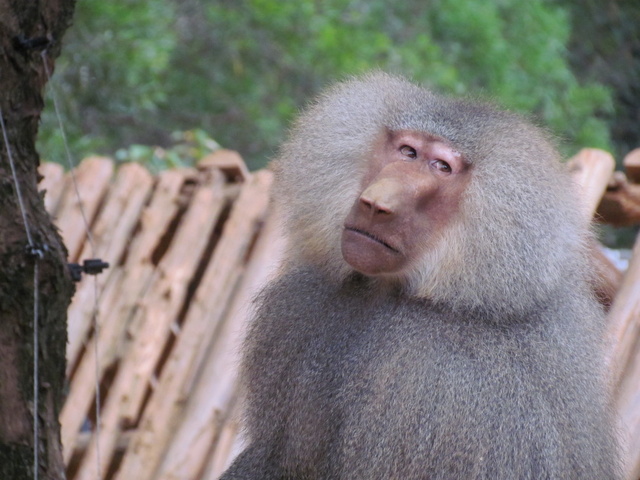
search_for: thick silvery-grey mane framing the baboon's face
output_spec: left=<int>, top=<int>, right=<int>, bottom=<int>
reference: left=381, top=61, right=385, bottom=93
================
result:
left=273, top=73, right=589, bottom=311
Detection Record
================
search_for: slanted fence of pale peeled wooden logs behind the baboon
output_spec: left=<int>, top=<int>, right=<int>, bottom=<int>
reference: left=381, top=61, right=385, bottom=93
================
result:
left=41, top=150, right=640, bottom=480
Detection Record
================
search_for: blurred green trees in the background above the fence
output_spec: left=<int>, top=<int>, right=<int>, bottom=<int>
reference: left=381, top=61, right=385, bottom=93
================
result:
left=39, top=0, right=640, bottom=169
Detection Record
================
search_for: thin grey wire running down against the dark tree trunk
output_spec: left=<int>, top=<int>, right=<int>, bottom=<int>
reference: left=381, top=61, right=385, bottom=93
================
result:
left=0, top=108, right=43, bottom=480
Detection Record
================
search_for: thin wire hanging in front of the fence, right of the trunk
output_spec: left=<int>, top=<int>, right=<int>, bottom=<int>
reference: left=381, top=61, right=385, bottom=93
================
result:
left=40, top=50, right=102, bottom=478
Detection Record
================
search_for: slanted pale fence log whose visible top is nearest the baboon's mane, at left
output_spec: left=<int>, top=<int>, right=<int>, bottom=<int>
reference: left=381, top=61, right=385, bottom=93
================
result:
left=117, top=172, right=271, bottom=480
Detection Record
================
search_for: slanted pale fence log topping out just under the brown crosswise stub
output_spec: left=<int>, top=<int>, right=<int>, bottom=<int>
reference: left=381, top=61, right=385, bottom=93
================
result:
left=76, top=171, right=225, bottom=480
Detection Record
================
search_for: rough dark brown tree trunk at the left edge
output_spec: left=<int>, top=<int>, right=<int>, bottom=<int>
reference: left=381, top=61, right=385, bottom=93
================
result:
left=0, top=0, right=75, bottom=480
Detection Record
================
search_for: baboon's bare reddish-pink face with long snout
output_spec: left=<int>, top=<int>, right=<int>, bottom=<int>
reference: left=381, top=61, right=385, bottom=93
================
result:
left=342, top=130, right=470, bottom=275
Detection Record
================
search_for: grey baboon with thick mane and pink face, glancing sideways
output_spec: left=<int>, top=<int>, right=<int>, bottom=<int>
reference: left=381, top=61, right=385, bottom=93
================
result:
left=222, top=73, right=621, bottom=480
